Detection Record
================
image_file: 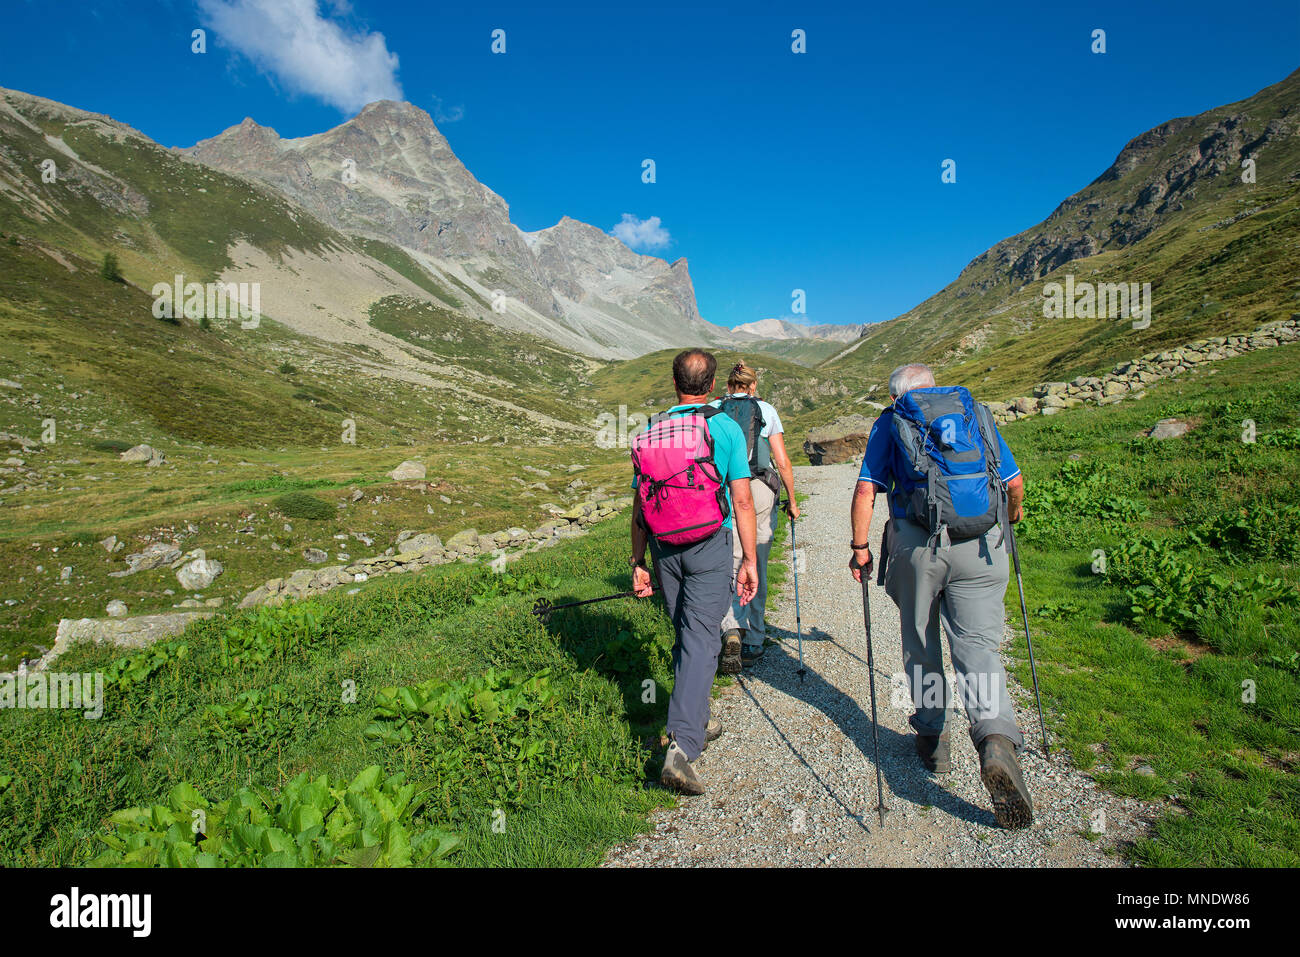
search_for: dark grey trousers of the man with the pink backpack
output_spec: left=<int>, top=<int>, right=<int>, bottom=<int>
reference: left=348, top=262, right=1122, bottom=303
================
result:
left=650, top=528, right=735, bottom=761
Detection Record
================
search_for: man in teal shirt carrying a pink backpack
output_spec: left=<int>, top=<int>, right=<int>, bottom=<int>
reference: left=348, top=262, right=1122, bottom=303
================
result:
left=628, top=348, right=758, bottom=794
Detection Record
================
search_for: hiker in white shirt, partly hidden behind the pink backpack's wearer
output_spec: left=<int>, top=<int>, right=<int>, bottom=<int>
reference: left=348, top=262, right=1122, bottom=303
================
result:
left=709, top=360, right=800, bottom=675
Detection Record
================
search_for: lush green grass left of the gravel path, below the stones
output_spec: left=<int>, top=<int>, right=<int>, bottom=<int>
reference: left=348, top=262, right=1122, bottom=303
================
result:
left=0, top=514, right=672, bottom=866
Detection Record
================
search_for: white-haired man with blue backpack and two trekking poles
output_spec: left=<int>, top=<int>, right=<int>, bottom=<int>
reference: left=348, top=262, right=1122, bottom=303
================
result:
left=849, top=364, right=1034, bottom=827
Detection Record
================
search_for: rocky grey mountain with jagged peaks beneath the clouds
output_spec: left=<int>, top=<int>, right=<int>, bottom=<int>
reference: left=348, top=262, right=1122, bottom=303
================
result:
left=179, top=100, right=732, bottom=358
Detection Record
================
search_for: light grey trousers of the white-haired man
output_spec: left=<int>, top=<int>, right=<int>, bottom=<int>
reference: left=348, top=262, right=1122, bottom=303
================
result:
left=885, top=518, right=1024, bottom=748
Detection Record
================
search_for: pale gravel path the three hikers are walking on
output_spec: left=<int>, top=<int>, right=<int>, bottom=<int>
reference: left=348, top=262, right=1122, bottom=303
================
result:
left=606, top=465, right=1158, bottom=867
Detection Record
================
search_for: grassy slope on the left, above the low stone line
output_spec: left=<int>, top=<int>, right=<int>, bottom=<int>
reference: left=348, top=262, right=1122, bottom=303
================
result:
left=0, top=231, right=627, bottom=668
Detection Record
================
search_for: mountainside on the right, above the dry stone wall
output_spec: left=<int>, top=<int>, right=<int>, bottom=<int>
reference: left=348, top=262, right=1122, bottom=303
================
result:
left=820, top=75, right=1300, bottom=399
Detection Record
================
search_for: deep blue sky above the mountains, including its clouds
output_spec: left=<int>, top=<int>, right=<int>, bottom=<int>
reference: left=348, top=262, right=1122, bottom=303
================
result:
left=0, top=0, right=1300, bottom=325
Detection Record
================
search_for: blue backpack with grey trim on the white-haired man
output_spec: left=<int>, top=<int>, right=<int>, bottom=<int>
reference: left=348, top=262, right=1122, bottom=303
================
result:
left=891, top=386, right=1006, bottom=549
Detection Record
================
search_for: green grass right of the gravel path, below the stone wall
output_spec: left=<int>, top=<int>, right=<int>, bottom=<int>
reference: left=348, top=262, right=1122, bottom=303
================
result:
left=1005, top=347, right=1300, bottom=866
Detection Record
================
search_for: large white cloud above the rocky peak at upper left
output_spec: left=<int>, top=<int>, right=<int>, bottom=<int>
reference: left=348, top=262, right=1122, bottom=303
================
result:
left=199, top=0, right=403, bottom=113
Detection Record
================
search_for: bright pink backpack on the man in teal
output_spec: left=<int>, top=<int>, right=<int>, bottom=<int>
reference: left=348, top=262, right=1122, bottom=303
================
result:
left=632, top=406, right=728, bottom=545
